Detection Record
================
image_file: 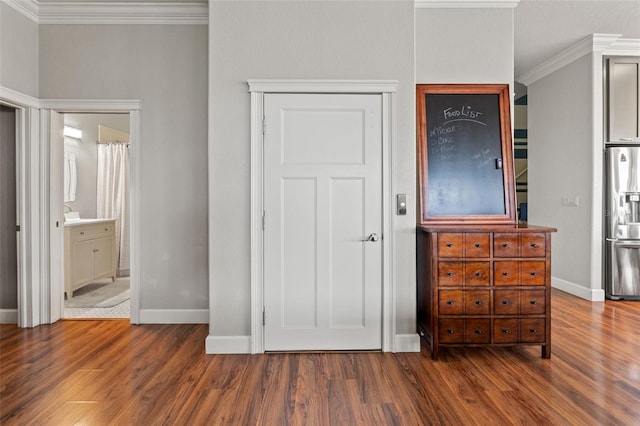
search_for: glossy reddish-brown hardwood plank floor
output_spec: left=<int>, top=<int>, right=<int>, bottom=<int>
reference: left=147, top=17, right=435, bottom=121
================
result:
left=0, top=290, right=640, bottom=425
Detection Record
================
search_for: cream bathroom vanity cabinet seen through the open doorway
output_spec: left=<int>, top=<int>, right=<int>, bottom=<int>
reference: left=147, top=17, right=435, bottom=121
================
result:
left=64, top=219, right=117, bottom=299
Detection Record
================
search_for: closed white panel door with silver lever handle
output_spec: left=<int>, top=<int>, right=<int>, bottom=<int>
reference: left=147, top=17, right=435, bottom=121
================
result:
left=264, top=94, right=382, bottom=351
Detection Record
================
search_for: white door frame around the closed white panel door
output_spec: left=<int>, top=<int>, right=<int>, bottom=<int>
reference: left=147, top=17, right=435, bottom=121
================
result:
left=247, top=79, right=398, bottom=354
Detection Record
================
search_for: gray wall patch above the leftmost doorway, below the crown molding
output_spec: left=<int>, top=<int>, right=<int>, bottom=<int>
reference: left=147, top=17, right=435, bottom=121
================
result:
left=0, top=2, right=38, bottom=97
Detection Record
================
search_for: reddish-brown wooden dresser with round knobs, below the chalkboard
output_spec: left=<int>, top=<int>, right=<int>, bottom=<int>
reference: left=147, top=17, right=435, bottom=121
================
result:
left=417, top=225, right=555, bottom=359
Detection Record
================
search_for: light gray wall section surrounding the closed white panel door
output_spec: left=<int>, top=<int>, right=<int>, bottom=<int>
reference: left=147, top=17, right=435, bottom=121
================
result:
left=209, top=1, right=416, bottom=336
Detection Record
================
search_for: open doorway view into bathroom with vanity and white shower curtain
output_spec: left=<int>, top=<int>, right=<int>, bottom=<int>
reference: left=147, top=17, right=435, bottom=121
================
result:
left=62, top=113, right=131, bottom=319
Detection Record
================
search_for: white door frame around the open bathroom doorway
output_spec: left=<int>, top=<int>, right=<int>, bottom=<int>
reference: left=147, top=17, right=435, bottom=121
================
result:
left=40, top=99, right=142, bottom=324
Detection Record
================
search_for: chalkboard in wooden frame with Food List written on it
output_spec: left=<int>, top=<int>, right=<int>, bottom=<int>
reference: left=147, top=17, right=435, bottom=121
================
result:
left=417, top=85, right=515, bottom=223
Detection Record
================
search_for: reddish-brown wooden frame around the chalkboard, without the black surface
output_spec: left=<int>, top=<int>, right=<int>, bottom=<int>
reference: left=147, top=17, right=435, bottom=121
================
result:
left=416, top=84, right=517, bottom=225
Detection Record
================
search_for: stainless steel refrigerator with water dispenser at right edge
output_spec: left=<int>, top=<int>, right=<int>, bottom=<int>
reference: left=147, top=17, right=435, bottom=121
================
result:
left=605, top=145, right=640, bottom=300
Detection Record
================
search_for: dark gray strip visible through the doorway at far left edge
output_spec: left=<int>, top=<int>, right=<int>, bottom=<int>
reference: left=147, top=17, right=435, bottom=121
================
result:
left=0, top=105, right=18, bottom=309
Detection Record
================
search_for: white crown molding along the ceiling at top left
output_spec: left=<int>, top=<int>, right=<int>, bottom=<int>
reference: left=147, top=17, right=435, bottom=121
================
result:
left=0, top=0, right=209, bottom=25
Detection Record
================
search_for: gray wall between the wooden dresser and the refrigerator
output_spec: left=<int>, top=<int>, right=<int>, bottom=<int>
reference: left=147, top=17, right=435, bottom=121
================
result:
left=527, top=54, right=602, bottom=294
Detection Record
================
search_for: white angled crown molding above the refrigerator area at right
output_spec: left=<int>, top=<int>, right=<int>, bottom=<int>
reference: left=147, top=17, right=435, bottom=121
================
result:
left=516, top=34, right=640, bottom=86
